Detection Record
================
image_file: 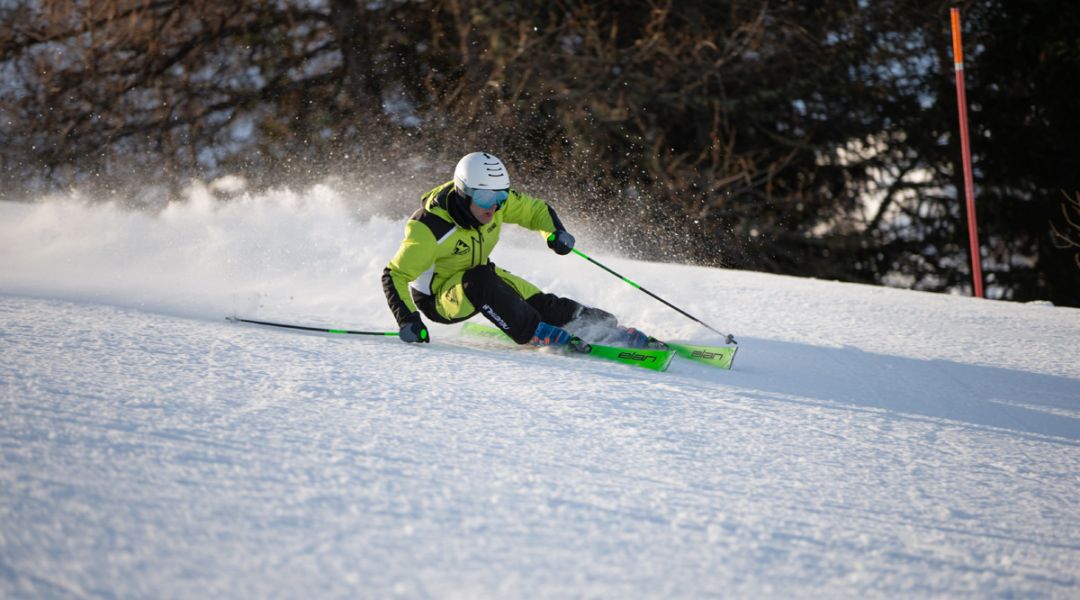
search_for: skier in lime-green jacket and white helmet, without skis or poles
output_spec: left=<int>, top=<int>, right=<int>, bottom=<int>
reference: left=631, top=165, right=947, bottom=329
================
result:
left=382, top=152, right=653, bottom=347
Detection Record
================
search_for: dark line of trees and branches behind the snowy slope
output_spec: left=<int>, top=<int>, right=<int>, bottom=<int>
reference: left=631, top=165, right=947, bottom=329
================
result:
left=6, top=0, right=1080, bottom=305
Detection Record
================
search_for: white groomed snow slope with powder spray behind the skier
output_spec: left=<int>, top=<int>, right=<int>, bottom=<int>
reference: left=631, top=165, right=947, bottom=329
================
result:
left=0, top=187, right=1080, bottom=598
